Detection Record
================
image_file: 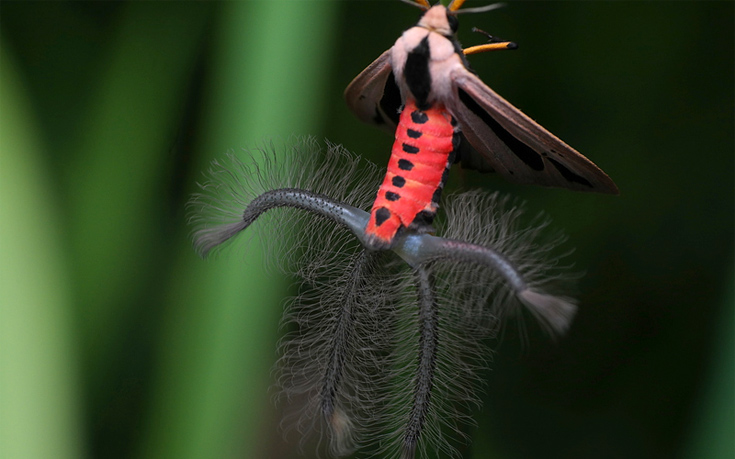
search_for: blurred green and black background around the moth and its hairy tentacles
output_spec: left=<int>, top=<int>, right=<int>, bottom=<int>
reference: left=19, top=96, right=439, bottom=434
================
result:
left=0, top=0, right=735, bottom=458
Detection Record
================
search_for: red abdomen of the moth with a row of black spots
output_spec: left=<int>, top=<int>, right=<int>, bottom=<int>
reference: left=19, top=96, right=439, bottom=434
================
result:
left=365, top=99, right=455, bottom=249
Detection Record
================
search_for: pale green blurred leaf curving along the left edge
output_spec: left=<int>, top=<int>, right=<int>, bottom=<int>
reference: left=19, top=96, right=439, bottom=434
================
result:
left=0, top=43, right=85, bottom=459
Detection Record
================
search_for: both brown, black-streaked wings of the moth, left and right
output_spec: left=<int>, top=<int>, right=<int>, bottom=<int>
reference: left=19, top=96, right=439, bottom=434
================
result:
left=345, top=50, right=618, bottom=194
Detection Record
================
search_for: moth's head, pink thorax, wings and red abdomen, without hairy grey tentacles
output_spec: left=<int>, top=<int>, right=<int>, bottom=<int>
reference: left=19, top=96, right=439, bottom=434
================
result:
left=345, top=0, right=618, bottom=248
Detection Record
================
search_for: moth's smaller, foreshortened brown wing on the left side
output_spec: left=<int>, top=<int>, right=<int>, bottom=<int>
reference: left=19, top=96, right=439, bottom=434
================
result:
left=345, top=49, right=403, bottom=134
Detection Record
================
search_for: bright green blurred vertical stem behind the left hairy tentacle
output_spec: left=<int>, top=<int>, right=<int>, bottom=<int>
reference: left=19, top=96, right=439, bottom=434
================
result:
left=143, top=1, right=337, bottom=458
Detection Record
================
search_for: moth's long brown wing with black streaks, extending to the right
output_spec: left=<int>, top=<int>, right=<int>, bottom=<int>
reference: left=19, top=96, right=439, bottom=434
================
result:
left=447, top=68, right=619, bottom=194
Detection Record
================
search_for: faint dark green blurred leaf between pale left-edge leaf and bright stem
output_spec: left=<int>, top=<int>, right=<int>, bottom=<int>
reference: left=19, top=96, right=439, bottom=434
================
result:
left=64, top=2, right=208, bottom=398
